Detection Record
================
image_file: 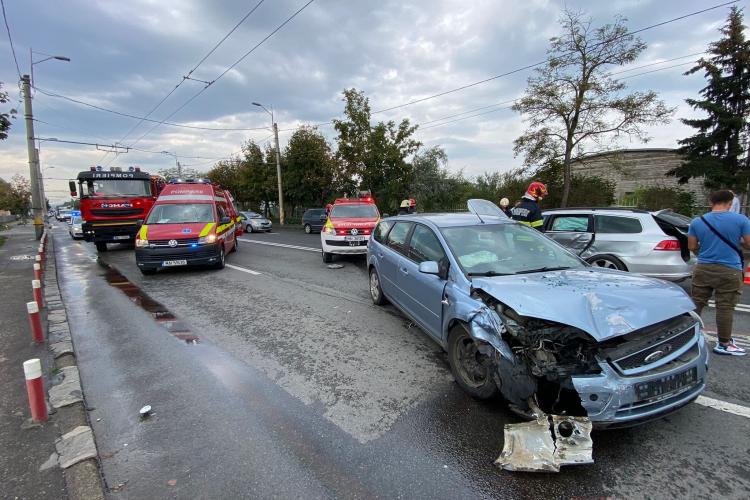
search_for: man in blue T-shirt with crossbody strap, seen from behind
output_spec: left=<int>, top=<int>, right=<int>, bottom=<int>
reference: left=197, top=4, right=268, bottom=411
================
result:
left=688, top=189, right=750, bottom=356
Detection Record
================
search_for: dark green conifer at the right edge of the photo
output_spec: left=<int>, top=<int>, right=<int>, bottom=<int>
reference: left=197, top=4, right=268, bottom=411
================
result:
left=669, top=6, right=750, bottom=192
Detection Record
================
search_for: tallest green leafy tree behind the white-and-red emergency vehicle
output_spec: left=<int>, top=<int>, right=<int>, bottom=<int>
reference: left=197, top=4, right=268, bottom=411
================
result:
left=333, top=89, right=421, bottom=209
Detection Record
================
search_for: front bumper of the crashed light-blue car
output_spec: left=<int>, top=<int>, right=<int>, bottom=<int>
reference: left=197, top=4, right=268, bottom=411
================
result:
left=572, top=326, right=708, bottom=428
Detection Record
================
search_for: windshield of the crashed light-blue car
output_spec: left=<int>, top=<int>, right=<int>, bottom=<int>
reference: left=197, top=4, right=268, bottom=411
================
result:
left=441, top=224, right=586, bottom=276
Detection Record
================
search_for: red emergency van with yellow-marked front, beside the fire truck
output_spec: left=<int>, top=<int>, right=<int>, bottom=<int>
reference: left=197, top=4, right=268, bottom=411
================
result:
left=135, top=179, right=242, bottom=274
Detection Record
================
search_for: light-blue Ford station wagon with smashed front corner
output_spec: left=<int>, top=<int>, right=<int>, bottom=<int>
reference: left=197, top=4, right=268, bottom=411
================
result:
left=367, top=200, right=708, bottom=428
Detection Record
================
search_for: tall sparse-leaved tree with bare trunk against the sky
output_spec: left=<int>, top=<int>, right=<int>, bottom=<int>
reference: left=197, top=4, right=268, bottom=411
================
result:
left=513, top=10, right=673, bottom=207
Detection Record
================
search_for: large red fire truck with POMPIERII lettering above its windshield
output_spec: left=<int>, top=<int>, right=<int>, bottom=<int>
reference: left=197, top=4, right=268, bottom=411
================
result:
left=70, top=167, right=166, bottom=252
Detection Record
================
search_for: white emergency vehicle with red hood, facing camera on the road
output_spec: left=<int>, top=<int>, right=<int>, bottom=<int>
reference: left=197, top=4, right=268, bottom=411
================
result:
left=320, top=194, right=380, bottom=263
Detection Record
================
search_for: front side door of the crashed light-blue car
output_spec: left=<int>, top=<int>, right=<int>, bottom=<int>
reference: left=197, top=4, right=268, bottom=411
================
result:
left=397, top=224, right=448, bottom=340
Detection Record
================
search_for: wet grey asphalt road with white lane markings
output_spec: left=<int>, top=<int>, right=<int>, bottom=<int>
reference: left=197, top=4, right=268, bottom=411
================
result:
left=56, top=228, right=750, bottom=498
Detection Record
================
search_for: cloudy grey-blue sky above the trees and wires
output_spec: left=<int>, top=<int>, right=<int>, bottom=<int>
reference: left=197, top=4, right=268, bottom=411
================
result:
left=0, top=0, right=747, bottom=201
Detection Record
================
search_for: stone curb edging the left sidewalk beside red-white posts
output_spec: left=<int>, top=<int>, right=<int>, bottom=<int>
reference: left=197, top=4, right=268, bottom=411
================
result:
left=44, top=232, right=105, bottom=500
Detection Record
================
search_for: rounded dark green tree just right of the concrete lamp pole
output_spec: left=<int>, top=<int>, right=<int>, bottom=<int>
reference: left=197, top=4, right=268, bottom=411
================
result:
left=282, top=127, right=340, bottom=214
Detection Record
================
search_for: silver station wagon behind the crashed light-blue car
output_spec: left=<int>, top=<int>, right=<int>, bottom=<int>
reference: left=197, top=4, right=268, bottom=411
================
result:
left=543, top=208, right=695, bottom=281
